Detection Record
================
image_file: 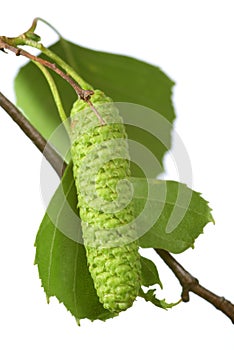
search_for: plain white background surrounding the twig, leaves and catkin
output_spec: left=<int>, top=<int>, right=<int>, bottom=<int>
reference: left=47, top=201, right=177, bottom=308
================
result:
left=0, top=0, right=234, bottom=350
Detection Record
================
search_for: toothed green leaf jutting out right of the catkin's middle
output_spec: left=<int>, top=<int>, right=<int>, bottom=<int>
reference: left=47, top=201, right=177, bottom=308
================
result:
left=132, top=178, right=214, bottom=253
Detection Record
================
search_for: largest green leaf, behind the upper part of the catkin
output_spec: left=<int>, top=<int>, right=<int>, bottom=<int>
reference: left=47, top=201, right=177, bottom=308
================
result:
left=15, top=39, right=175, bottom=177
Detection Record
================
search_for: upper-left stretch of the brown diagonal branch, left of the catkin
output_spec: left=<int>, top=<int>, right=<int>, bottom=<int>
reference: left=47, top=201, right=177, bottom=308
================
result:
left=0, top=92, right=66, bottom=177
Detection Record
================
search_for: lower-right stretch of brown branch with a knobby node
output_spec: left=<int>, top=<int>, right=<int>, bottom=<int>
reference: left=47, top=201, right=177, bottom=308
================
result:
left=155, top=249, right=234, bottom=323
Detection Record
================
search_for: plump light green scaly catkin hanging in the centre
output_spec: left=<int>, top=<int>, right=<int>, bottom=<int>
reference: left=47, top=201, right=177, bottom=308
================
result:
left=71, top=90, right=141, bottom=314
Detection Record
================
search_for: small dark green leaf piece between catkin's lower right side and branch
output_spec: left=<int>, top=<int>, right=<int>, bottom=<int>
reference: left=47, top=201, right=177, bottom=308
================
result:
left=141, top=256, right=163, bottom=288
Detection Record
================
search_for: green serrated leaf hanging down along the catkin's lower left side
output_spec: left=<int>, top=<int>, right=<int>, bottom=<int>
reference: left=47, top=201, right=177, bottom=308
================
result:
left=35, top=166, right=114, bottom=320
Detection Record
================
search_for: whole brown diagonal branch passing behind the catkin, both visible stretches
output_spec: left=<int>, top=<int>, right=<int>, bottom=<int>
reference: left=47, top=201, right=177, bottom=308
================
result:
left=0, top=93, right=234, bottom=323
